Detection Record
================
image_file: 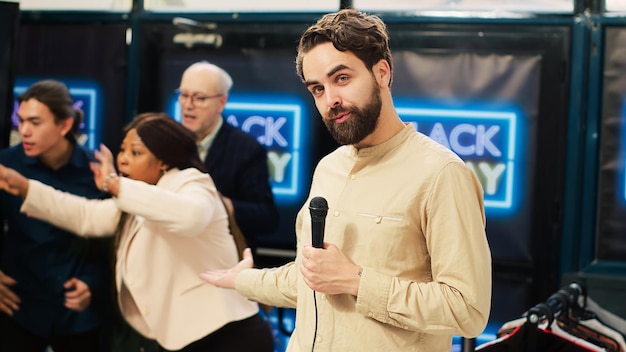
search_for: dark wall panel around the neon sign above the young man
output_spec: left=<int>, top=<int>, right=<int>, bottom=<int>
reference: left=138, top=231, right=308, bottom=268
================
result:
left=15, top=22, right=128, bottom=150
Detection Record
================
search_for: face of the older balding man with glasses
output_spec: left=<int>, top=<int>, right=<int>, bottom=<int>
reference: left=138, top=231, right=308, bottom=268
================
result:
left=179, top=69, right=228, bottom=141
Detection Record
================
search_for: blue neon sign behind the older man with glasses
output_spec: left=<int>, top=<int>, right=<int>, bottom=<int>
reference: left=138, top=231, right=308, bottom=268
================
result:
left=167, top=93, right=310, bottom=204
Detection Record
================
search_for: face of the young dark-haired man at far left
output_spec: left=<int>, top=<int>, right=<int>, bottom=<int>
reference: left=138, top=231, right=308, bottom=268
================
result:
left=17, top=99, right=72, bottom=157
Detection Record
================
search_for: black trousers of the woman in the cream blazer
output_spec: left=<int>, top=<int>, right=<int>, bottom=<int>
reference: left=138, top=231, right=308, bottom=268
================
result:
left=110, top=314, right=274, bottom=352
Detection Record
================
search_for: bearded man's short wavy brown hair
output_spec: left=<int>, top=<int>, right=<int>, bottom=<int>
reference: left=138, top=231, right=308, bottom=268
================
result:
left=296, top=9, right=393, bottom=86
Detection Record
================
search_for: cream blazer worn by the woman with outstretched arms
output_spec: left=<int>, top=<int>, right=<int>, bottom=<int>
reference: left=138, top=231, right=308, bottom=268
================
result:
left=21, top=168, right=258, bottom=350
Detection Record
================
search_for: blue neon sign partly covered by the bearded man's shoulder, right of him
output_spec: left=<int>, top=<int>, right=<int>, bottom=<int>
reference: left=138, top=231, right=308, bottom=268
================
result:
left=395, top=99, right=523, bottom=213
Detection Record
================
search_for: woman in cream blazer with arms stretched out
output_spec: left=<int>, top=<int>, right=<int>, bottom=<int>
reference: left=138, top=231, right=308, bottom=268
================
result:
left=0, top=113, right=273, bottom=352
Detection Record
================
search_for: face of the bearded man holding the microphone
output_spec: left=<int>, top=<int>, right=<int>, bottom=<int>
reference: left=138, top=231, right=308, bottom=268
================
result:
left=303, top=43, right=382, bottom=147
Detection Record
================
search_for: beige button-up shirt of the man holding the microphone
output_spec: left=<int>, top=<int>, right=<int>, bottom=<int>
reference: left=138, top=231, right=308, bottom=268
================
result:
left=236, top=125, right=491, bottom=352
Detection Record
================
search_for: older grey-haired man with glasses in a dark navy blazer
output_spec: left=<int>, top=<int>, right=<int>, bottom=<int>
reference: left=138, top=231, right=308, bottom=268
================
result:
left=178, top=61, right=278, bottom=254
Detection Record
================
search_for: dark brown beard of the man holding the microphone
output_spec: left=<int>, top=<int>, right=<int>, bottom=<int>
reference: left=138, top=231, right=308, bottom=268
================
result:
left=324, top=81, right=382, bottom=145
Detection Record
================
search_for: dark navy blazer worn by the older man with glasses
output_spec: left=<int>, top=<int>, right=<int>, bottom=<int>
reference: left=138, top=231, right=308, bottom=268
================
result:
left=204, top=121, right=278, bottom=248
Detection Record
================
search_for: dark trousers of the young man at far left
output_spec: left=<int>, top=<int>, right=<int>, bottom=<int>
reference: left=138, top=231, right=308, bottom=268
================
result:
left=0, top=313, right=100, bottom=352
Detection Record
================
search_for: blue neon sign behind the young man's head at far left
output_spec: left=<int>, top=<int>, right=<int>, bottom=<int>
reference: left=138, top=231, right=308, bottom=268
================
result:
left=11, top=78, right=101, bottom=149
